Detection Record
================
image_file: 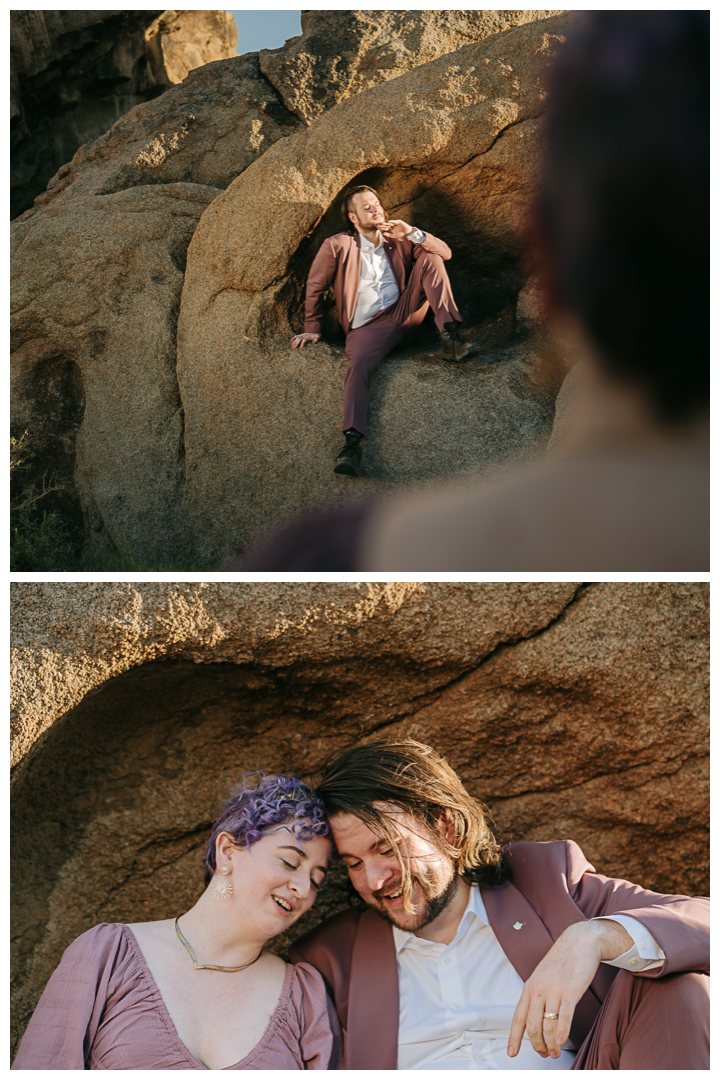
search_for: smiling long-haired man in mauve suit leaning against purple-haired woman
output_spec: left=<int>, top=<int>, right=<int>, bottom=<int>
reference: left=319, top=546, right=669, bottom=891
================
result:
left=290, top=740, right=709, bottom=1069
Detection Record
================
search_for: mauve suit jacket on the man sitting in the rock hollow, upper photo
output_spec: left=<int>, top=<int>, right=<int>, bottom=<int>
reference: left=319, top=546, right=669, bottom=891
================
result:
left=305, top=229, right=452, bottom=334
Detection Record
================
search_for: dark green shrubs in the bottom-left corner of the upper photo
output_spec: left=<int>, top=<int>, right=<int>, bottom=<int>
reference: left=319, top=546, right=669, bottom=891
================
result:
left=10, top=431, right=217, bottom=573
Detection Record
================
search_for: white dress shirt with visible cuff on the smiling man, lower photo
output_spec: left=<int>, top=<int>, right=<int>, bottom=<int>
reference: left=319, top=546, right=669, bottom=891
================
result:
left=393, top=886, right=665, bottom=1069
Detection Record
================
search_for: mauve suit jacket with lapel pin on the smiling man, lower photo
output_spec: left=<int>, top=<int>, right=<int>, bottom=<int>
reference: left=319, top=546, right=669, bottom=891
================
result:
left=290, top=840, right=710, bottom=1069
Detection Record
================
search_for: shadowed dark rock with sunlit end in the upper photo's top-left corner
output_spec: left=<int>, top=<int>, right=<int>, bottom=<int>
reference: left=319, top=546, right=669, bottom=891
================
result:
left=10, top=11, right=237, bottom=217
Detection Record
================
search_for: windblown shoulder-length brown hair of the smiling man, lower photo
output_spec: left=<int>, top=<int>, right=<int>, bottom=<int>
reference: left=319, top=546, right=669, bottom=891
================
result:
left=314, top=738, right=505, bottom=910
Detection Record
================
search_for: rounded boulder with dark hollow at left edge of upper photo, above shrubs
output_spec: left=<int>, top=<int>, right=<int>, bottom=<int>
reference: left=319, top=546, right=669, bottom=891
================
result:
left=12, top=184, right=217, bottom=555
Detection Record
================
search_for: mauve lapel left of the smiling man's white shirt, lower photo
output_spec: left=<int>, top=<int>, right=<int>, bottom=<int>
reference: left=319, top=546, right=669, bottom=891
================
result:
left=345, top=910, right=399, bottom=1069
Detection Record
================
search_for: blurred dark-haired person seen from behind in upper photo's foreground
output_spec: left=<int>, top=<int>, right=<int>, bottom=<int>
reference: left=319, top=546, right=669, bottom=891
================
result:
left=237, top=10, right=710, bottom=573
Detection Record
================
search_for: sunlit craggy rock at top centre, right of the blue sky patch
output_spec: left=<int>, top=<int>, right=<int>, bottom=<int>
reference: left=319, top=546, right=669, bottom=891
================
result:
left=260, top=9, right=560, bottom=123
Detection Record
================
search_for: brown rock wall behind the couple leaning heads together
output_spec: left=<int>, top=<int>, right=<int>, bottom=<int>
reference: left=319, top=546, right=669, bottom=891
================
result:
left=12, top=582, right=709, bottom=1054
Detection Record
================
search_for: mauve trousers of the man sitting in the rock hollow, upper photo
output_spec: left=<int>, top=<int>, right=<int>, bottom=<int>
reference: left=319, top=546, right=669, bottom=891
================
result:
left=342, top=252, right=462, bottom=433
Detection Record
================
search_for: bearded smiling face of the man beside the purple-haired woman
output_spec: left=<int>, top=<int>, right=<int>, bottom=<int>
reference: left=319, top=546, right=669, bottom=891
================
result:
left=330, top=806, right=457, bottom=930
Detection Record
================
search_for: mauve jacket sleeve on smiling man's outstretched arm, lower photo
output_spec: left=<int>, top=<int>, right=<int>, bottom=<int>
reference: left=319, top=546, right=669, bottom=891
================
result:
left=568, top=840, right=710, bottom=978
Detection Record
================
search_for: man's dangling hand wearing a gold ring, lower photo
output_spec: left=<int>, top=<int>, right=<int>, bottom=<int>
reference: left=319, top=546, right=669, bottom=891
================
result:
left=507, top=919, right=633, bottom=1057
